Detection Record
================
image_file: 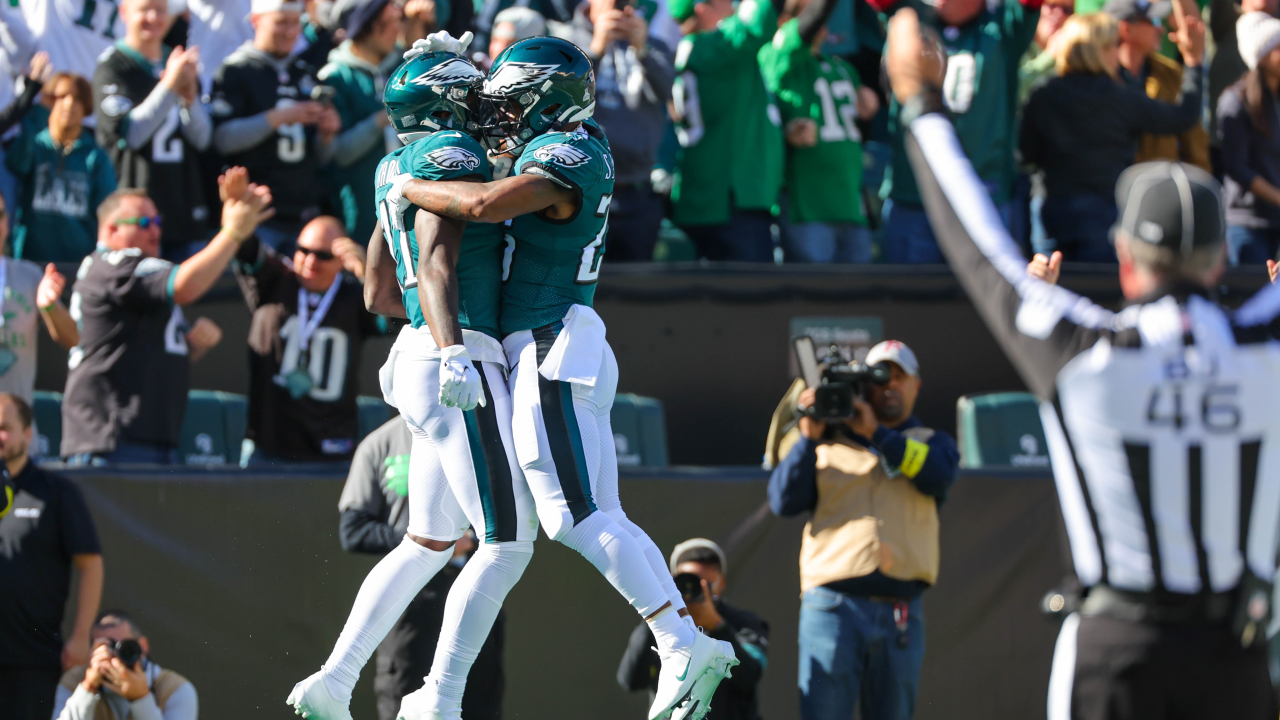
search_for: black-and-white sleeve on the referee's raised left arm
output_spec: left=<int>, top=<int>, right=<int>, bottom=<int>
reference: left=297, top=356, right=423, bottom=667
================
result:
left=904, top=109, right=1115, bottom=400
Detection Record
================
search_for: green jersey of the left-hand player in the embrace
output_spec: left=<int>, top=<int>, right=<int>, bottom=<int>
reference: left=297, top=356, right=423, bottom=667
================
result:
left=374, top=131, right=503, bottom=340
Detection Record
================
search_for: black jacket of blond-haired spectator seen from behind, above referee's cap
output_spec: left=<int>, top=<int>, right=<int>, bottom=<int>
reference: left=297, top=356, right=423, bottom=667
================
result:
left=1018, top=69, right=1203, bottom=197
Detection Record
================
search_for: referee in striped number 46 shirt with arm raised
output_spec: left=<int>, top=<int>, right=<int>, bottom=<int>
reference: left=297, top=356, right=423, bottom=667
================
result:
left=886, top=10, right=1280, bottom=720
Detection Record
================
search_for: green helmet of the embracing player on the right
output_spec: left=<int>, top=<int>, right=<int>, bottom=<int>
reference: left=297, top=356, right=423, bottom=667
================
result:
left=480, top=37, right=595, bottom=155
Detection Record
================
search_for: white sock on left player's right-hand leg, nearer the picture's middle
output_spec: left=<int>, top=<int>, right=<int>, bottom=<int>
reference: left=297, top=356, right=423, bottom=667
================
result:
left=426, top=542, right=534, bottom=710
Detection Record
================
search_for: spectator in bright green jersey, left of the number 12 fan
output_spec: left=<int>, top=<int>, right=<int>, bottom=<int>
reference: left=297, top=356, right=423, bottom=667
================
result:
left=668, top=0, right=788, bottom=263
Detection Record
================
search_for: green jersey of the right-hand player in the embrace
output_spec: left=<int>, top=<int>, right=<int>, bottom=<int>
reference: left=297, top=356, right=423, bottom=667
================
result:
left=502, top=123, right=613, bottom=334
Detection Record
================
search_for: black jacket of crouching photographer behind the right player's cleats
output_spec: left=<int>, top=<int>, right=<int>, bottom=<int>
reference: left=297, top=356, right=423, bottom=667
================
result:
left=618, top=600, right=769, bottom=720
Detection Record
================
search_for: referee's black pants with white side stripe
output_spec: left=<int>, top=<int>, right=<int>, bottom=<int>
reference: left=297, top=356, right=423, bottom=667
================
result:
left=1050, top=609, right=1280, bottom=720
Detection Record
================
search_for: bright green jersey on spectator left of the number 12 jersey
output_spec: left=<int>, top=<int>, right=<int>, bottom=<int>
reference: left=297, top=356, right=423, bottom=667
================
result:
left=671, top=0, right=783, bottom=225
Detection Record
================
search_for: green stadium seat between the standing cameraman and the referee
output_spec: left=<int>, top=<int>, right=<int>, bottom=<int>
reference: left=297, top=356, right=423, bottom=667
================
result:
left=956, top=392, right=1048, bottom=468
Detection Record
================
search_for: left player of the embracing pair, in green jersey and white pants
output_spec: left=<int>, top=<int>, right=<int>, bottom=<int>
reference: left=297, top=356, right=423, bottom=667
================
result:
left=288, top=38, right=538, bottom=720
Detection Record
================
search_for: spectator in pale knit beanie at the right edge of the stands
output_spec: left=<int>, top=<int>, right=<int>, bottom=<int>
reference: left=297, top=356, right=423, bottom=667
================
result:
left=1217, top=13, right=1280, bottom=264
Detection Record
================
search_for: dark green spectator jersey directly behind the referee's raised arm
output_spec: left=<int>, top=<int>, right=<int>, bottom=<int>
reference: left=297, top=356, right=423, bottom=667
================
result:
left=881, top=0, right=1039, bottom=205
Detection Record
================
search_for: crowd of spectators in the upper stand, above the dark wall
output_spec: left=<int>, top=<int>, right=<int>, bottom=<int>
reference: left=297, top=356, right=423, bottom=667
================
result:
left=0, top=0, right=1264, bottom=264
